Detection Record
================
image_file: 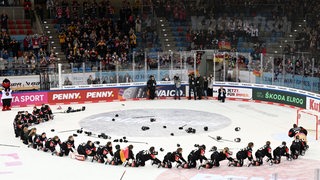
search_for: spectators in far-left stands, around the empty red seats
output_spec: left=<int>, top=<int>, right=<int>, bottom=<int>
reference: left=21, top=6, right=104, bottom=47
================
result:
left=0, top=1, right=56, bottom=76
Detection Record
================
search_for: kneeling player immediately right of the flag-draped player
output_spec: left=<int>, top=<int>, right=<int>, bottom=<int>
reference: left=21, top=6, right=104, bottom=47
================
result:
left=136, top=146, right=161, bottom=167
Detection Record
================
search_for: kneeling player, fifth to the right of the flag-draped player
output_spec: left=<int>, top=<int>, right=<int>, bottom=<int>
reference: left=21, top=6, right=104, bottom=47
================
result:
left=229, top=142, right=253, bottom=167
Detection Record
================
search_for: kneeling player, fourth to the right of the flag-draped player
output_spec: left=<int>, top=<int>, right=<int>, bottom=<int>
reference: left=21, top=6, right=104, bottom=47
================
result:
left=199, top=146, right=234, bottom=169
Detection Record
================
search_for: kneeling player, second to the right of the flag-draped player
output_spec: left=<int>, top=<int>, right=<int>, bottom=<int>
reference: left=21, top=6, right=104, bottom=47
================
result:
left=162, top=148, right=187, bottom=168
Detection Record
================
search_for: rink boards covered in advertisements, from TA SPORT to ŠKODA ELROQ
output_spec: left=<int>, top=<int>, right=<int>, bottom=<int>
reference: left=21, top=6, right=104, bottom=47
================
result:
left=0, top=81, right=320, bottom=112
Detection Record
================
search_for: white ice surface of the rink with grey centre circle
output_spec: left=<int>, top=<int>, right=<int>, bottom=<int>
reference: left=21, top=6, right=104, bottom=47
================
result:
left=0, top=100, right=320, bottom=180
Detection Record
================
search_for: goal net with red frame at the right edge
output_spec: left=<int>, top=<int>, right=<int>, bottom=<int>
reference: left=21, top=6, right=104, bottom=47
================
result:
left=296, top=109, right=320, bottom=140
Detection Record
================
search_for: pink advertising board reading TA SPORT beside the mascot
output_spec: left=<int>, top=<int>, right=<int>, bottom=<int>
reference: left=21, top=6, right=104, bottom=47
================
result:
left=0, top=91, right=48, bottom=106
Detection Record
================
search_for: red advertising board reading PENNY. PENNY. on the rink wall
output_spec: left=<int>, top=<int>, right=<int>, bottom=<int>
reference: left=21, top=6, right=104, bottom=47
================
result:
left=48, top=88, right=118, bottom=103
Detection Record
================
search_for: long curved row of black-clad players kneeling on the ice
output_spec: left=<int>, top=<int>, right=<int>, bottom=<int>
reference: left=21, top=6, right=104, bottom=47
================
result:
left=14, top=108, right=308, bottom=169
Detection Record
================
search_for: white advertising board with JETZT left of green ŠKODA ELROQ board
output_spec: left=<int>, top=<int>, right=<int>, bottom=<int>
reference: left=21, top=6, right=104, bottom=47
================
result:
left=213, top=86, right=252, bottom=99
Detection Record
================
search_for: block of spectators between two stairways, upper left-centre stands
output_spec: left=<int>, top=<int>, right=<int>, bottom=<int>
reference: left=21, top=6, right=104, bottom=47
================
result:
left=50, top=0, right=158, bottom=70
